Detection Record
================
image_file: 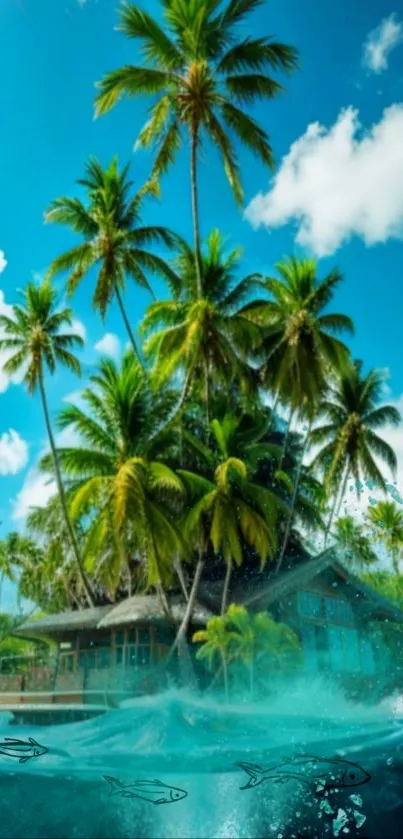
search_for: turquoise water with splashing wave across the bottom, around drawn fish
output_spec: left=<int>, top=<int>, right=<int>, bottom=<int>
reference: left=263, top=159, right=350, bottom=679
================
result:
left=0, top=681, right=403, bottom=839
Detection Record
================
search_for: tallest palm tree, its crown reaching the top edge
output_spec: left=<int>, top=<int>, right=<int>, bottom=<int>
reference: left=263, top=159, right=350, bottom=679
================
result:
left=96, top=0, right=297, bottom=297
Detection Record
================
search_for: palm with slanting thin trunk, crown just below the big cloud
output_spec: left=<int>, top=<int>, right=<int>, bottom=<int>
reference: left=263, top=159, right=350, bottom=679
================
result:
left=247, top=257, right=353, bottom=571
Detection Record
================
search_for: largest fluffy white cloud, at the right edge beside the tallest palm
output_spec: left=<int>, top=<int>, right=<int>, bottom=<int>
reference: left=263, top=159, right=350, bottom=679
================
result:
left=245, top=103, right=403, bottom=257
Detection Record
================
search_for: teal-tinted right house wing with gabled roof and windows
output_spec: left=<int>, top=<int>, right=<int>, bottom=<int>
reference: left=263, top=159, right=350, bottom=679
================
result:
left=199, top=548, right=403, bottom=690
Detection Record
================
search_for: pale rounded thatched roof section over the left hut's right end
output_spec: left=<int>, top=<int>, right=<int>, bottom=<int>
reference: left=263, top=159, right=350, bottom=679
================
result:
left=98, top=594, right=213, bottom=629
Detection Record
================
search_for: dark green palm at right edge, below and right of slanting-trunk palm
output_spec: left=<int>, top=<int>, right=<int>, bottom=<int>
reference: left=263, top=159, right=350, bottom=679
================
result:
left=311, top=361, right=400, bottom=542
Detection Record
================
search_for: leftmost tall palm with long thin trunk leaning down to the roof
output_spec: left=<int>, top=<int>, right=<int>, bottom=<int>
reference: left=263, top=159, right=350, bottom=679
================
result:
left=0, top=280, right=93, bottom=606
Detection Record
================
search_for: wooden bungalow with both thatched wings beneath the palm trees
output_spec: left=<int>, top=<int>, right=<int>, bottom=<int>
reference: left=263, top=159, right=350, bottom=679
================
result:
left=4, top=549, right=403, bottom=702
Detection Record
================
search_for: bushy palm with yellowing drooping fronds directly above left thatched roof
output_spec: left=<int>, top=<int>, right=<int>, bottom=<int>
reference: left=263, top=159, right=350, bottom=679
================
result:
left=40, top=350, right=184, bottom=608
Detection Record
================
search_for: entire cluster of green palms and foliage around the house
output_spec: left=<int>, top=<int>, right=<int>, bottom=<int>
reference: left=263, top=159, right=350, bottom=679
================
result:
left=0, top=0, right=403, bottom=692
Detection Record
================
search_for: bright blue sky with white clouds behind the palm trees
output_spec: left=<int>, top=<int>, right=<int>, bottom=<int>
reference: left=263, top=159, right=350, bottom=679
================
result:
left=0, top=0, right=403, bottom=607
